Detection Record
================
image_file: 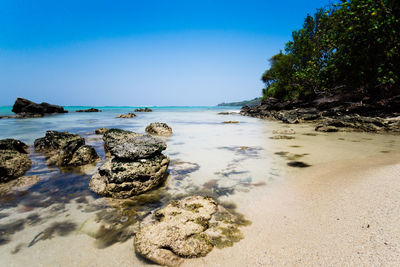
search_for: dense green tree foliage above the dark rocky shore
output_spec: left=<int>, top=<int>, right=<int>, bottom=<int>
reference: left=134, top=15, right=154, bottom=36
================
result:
left=262, top=0, right=400, bottom=100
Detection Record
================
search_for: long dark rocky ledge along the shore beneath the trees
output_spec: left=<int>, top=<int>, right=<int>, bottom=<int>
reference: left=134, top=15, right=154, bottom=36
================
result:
left=240, top=96, right=400, bottom=133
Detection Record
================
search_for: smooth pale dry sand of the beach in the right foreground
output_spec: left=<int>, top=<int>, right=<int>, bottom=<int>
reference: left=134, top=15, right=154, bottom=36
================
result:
left=184, top=153, right=400, bottom=266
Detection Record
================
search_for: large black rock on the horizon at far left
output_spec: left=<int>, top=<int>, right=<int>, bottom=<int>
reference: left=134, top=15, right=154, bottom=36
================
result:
left=12, top=98, right=68, bottom=117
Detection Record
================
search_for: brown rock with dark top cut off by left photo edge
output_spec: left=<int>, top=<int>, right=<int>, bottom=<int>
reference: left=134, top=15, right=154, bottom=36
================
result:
left=0, top=139, right=32, bottom=183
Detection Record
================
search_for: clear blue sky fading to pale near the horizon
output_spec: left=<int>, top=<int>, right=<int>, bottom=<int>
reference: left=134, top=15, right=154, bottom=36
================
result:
left=0, top=0, right=328, bottom=106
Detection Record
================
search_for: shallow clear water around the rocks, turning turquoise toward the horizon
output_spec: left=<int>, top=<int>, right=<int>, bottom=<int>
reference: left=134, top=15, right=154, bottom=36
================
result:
left=0, top=107, right=400, bottom=266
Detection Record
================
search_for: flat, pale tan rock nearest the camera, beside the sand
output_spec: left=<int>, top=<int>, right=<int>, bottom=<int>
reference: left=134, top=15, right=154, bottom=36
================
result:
left=134, top=196, right=247, bottom=266
